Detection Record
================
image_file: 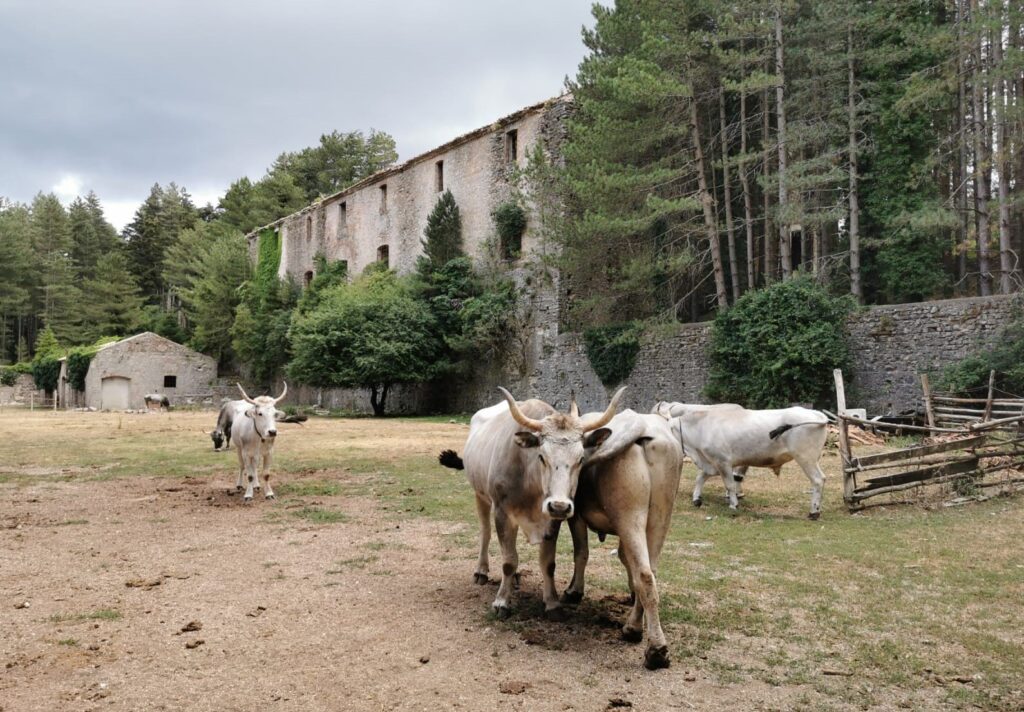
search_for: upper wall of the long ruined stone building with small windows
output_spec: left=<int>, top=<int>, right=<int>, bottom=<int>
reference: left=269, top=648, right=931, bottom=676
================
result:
left=248, top=96, right=570, bottom=284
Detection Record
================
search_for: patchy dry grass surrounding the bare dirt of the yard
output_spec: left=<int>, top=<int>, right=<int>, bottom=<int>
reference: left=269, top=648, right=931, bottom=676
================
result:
left=0, top=410, right=1024, bottom=710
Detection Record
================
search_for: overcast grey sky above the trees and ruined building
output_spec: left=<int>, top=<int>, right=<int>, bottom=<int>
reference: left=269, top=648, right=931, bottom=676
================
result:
left=0, top=0, right=598, bottom=228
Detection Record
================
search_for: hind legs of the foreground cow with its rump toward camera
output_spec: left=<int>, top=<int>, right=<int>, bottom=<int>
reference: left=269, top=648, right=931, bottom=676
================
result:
left=618, top=522, right=669, bottom=670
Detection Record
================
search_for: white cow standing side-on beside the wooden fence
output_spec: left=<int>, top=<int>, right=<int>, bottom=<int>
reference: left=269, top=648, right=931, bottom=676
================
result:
left=669, top=404, right=828, bottom=519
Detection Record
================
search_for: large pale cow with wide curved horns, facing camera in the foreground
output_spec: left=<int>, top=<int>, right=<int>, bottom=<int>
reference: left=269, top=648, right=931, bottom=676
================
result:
left=438, top=388, right=625, bottom=620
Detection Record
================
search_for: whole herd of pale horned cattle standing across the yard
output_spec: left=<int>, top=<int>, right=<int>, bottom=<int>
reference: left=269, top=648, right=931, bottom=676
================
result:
left=210, top=383, right=828, bottom=670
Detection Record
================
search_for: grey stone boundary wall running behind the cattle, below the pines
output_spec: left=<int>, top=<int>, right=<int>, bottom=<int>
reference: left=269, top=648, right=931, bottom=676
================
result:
left=454, top=297, right=1014, bottom=415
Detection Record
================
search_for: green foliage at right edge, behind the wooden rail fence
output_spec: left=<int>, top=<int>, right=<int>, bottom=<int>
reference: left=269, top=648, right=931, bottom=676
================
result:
left=936, top=303, right=1024, bottom=395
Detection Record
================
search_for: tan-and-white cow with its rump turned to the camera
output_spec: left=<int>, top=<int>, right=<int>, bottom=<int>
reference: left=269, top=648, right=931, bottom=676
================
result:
left=563, top=410, right=683, bottom=670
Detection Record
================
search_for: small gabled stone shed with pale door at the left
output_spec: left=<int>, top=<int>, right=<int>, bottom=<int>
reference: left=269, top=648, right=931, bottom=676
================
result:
left=85, top=331, right=217, bottom=411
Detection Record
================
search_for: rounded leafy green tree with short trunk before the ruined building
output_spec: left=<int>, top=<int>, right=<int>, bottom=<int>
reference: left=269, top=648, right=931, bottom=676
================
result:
left=289, top=271, right=441, bottom=415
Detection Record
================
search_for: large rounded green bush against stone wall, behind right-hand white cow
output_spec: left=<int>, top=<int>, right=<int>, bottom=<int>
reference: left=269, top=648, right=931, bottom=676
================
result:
left=706, top=277, right=853, bottom=408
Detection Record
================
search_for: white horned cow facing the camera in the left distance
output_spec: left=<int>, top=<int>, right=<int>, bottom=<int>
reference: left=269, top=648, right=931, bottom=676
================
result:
left=231, top=383, right=288, bottom=504
